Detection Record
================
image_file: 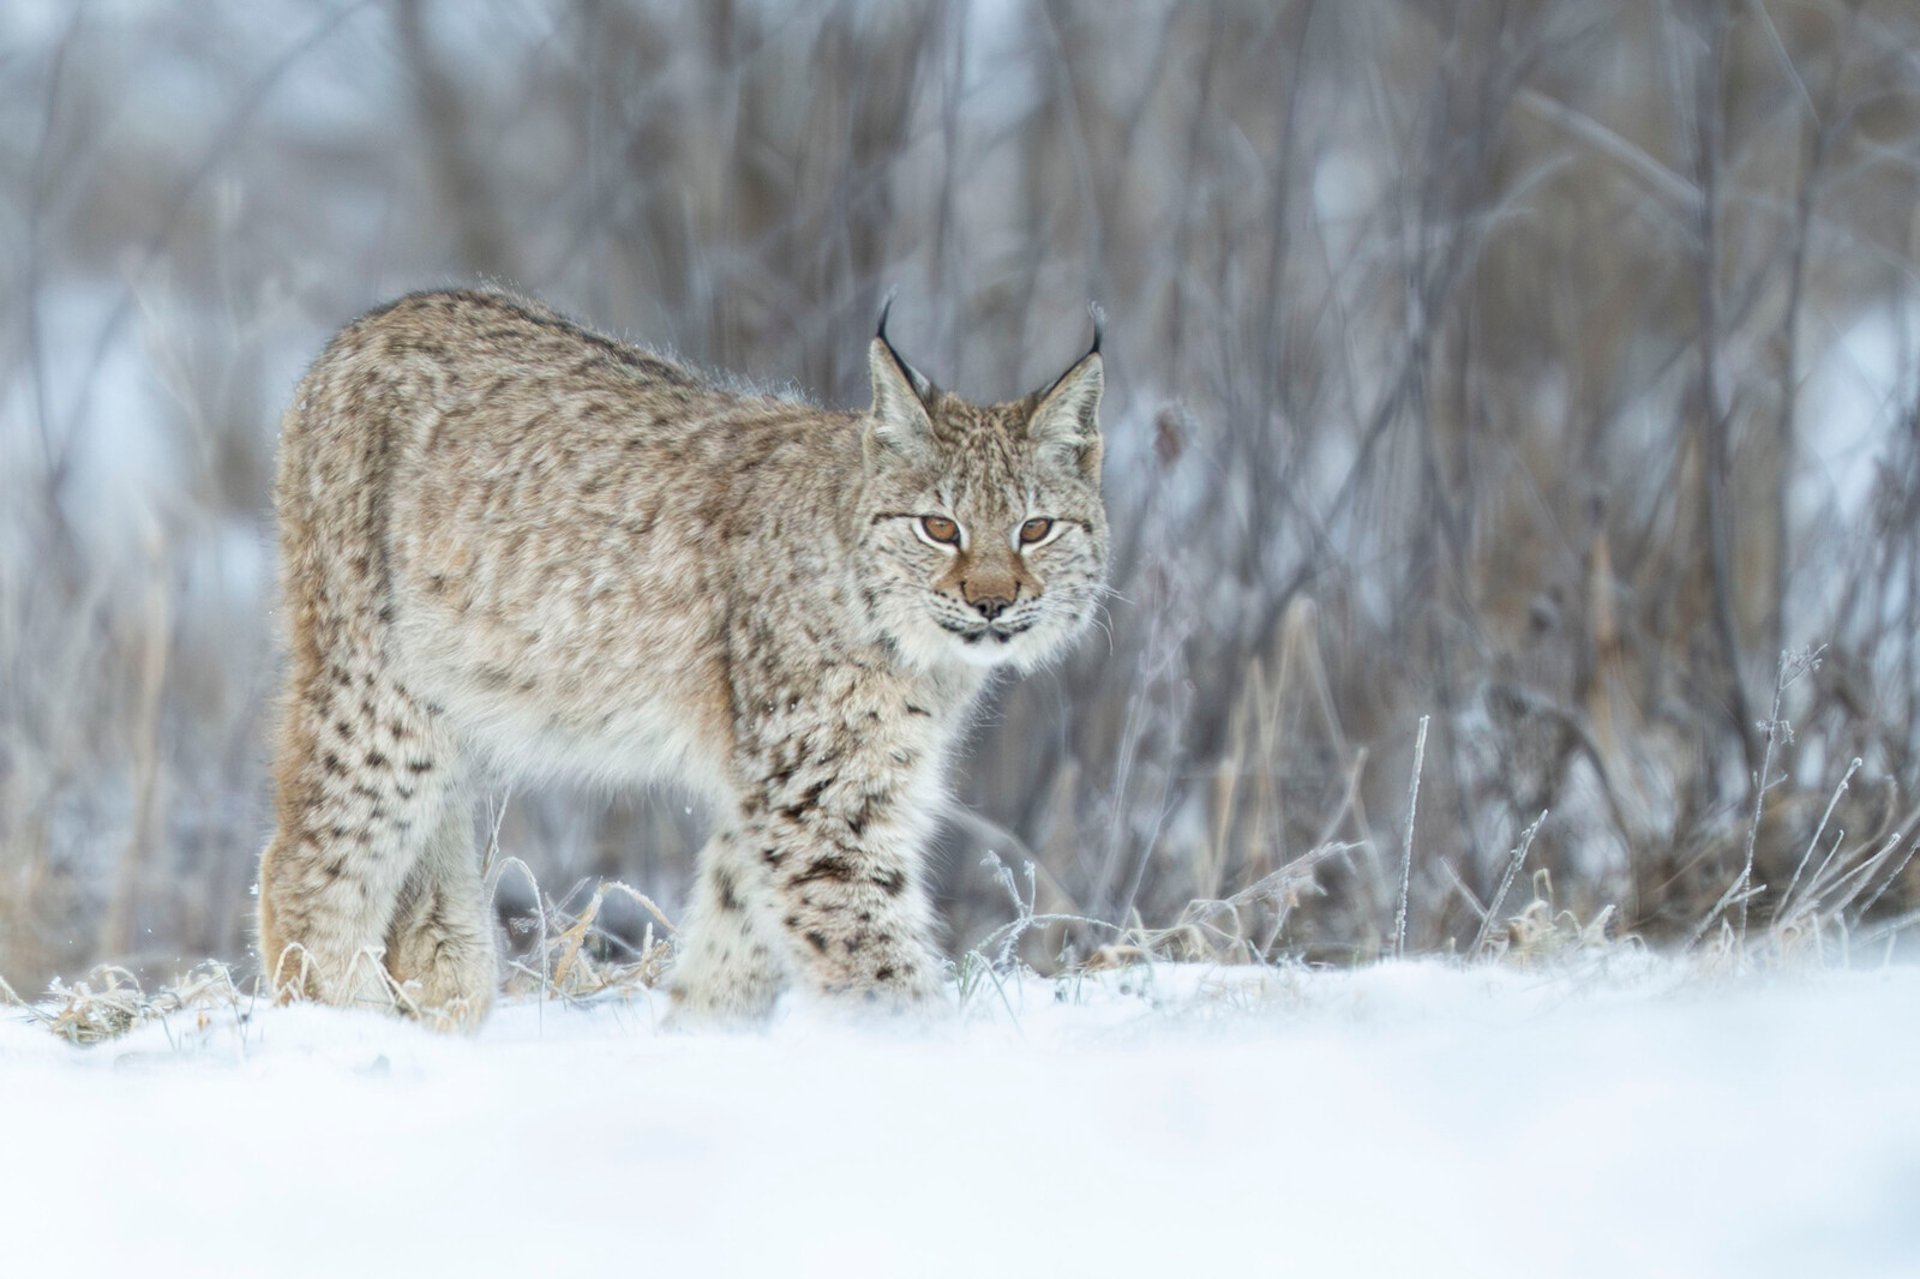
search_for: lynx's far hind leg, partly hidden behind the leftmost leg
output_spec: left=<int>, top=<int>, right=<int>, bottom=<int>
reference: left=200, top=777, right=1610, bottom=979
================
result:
left=386, top=789, right=499, bottom=1029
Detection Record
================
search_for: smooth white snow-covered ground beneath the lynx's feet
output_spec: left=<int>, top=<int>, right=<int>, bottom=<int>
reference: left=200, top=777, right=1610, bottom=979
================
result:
left=0, top=951, right=1920, bottom=1279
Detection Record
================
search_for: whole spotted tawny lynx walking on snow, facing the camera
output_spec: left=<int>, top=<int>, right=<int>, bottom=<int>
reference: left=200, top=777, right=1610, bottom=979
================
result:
left=259, top=292, right=1108, bottom=1024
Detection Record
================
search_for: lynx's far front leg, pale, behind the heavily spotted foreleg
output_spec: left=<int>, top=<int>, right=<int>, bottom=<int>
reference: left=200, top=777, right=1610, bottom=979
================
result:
left=672, top=833, right=787, bottom=1022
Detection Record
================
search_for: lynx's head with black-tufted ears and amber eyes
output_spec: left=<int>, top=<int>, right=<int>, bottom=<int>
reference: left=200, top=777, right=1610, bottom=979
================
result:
left=858, top=311, right=1106, bottom=670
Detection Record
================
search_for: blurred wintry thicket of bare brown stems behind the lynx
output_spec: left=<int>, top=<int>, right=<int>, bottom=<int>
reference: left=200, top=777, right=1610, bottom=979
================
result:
left=0, top=0, right=1920, bottom=991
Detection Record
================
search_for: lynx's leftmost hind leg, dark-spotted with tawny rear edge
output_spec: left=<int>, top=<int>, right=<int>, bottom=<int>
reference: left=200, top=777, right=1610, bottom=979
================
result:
left=259, top=663, right=453, bottom=1008
